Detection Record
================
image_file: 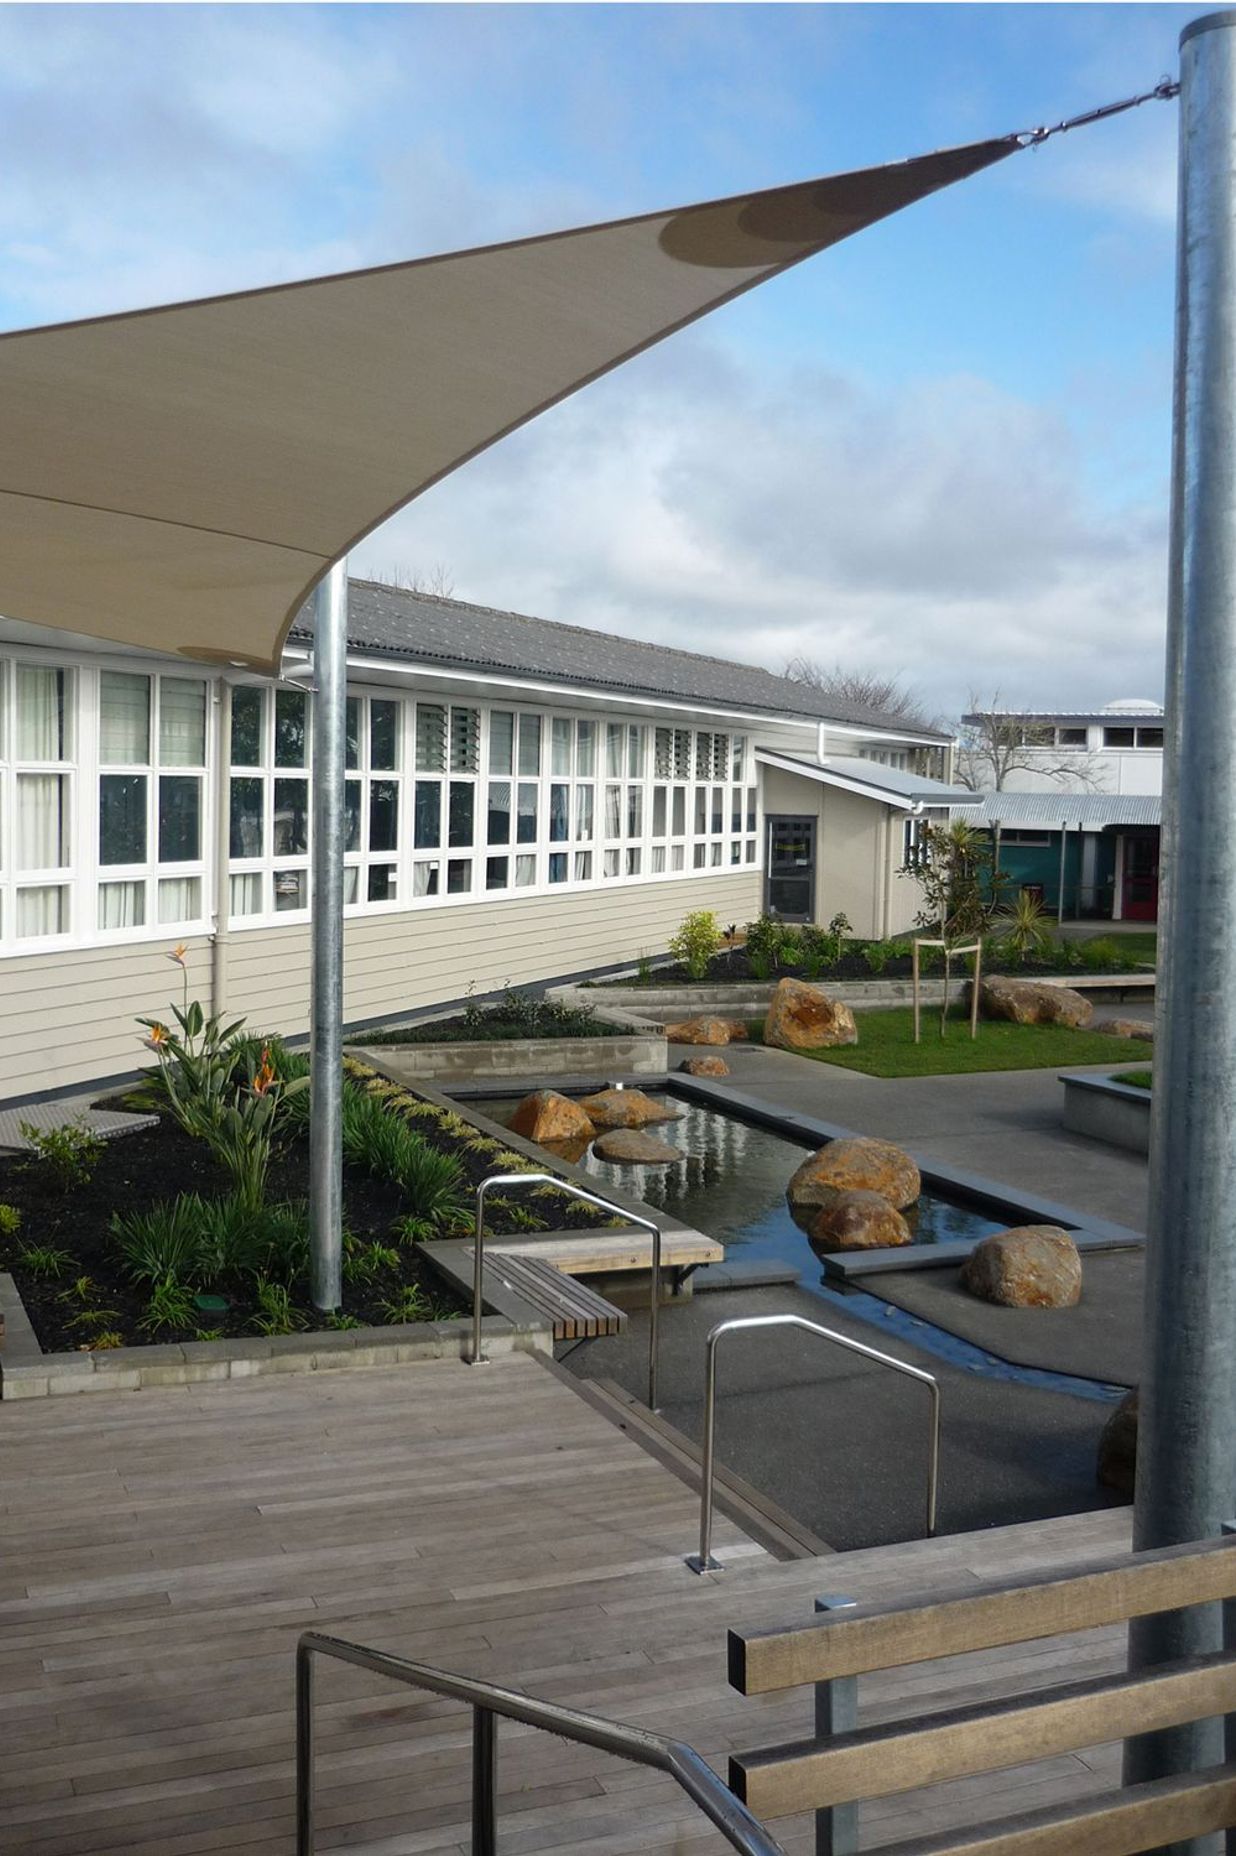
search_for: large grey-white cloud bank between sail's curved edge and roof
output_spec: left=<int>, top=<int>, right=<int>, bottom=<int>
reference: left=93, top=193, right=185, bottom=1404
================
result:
left=353, top=336, right=1165, bottom=713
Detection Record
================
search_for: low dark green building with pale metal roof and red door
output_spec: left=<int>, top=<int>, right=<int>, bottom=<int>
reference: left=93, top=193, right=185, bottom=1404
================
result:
left=956, top=789, right=1162, bottom=922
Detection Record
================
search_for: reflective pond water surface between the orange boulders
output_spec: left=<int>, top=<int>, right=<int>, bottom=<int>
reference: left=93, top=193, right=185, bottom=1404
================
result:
left=477, top=1097, right=1002, bottom=1277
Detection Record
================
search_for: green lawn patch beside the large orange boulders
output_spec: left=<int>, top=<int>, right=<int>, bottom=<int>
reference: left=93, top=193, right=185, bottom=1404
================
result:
left=752, top=1006, right=1134, bottom=1076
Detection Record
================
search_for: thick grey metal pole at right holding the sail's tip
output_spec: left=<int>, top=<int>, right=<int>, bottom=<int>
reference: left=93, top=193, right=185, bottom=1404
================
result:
left=1127, top=11, right=1236, bottom=1818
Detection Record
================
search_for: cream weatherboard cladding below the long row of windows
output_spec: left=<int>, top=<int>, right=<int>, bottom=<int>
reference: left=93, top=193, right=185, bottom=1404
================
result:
left=0, top=870, right=761, bottom=1101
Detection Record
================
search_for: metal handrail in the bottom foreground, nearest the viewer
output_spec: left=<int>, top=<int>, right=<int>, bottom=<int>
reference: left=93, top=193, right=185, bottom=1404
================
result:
left=297, top=1630, right=785, bottom=1856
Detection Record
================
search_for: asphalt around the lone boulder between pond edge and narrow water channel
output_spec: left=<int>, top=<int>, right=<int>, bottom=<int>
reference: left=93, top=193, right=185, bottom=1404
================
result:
left=865, top=1251, right=1145, bottom=1386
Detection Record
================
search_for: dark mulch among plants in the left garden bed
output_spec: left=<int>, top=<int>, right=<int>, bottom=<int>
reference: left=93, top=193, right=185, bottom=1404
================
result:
left=0, top=1091, right=586, bottom=1353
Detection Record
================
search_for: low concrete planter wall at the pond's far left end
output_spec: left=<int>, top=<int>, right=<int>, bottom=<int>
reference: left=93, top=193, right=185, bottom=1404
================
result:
left=347, top=1026, right=666, bottom=1084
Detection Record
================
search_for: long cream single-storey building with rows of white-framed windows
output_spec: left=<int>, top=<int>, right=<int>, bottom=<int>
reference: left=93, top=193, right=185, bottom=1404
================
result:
left=0, top=581, right=972, bottom=1101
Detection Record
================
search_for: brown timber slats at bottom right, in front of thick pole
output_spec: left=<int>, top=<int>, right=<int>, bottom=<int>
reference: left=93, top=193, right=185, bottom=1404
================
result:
left=729, top=1540, right=1236, bottom=1856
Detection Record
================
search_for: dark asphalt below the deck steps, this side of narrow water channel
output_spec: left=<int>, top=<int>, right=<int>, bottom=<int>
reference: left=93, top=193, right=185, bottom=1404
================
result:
left=564, top=1288, right=1115, bottom=1552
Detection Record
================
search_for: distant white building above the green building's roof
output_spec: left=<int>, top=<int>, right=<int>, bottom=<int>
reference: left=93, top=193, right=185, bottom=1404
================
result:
left=961, top=696, right=1164, bottom=793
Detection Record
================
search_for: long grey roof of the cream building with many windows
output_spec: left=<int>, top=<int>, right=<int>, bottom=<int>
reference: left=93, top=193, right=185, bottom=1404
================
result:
left=291, top=579, right=948, bottom=741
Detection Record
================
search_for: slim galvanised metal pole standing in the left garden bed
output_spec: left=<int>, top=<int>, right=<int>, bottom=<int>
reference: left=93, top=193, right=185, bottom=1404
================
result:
left=310, top=561, right=347, bottom=1310
